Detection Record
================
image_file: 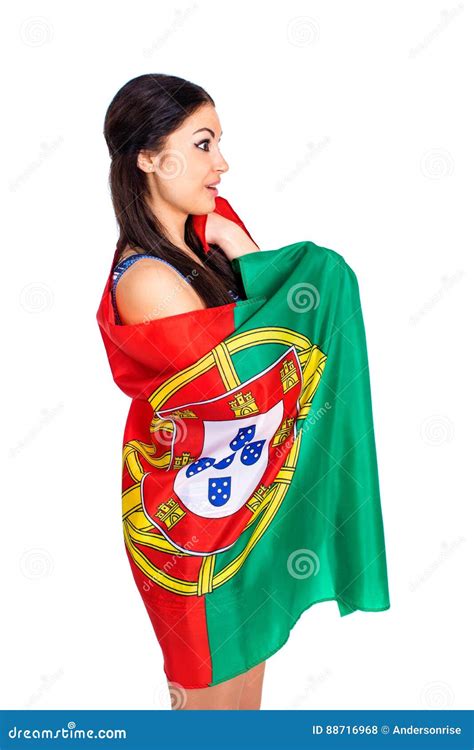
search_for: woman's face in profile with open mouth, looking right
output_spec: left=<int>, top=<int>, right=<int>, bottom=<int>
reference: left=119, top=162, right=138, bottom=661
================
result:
left=137, top=104, right=229, bottom=215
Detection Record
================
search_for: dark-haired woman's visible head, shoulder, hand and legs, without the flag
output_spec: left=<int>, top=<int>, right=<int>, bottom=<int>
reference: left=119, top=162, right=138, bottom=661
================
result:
left=104, top=74, right=265, bottom=709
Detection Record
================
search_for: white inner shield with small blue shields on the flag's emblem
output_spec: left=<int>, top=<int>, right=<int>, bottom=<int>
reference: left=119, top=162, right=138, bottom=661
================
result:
left=174, top=401, right=283, bottom=518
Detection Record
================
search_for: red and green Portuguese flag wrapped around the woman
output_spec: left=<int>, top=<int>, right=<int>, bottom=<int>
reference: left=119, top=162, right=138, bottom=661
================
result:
left=97, top=197, right=390, bottom=688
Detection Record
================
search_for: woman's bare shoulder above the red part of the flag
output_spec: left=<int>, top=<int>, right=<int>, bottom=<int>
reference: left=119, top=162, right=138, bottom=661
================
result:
left=115, top=258, right=206, bottom=325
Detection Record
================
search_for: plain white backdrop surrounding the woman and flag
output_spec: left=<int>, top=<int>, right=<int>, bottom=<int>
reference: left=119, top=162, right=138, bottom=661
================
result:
left=0, top=0, right=474, bottom=710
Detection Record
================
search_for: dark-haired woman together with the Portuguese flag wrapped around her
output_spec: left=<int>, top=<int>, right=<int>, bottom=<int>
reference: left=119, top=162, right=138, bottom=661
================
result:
left=97, top=70, right=390, bottom=709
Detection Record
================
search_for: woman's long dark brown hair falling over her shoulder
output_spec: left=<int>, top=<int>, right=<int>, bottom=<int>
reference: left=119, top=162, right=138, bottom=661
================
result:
left=104, top=73, right=244, bottom=307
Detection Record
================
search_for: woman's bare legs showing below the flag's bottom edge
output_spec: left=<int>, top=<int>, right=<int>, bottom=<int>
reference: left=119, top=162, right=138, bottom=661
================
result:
left=168, top=672, right=248, bottom=711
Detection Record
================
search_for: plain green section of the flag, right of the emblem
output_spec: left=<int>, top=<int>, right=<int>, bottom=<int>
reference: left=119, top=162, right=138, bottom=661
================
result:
left=206, top=242, right=390, bottom=684
